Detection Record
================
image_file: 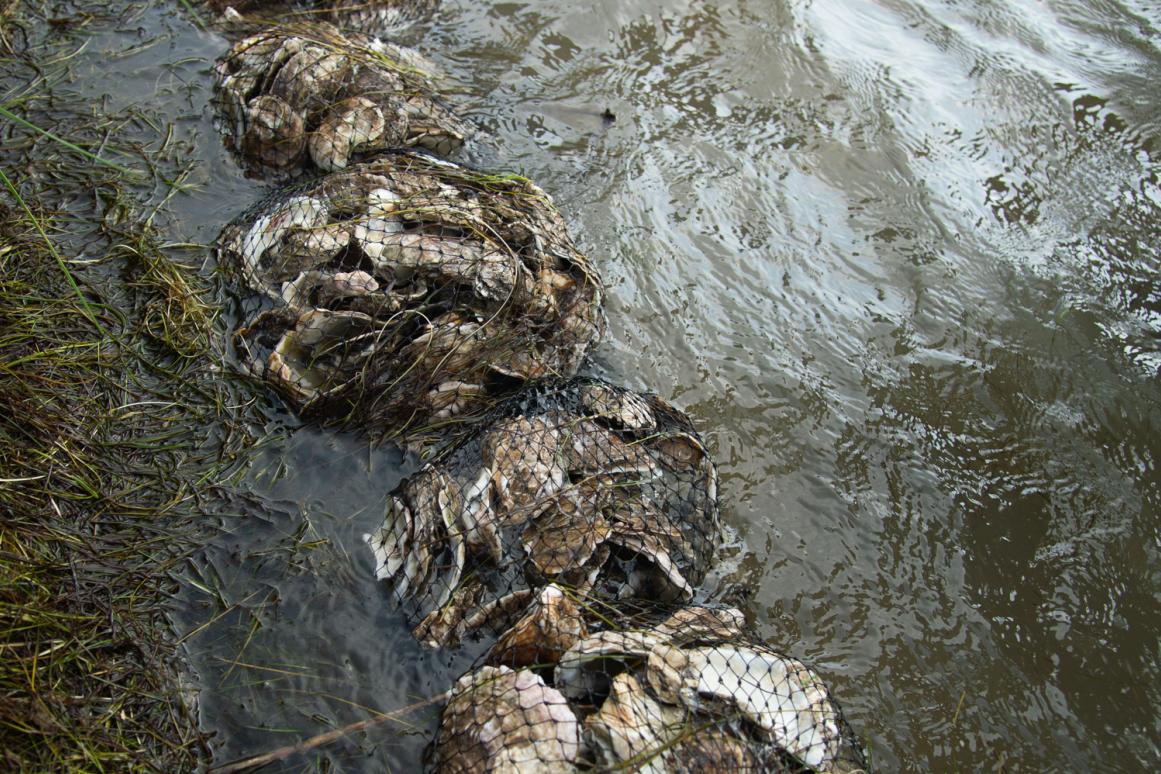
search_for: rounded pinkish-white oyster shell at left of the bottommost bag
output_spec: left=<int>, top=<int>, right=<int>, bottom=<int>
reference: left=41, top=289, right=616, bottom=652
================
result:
left=435, top=666, right=581, bottom=774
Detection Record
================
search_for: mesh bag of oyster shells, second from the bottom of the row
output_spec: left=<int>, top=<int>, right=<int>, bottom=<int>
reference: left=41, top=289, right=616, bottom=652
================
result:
left=368, top=378, right=719, bottom=649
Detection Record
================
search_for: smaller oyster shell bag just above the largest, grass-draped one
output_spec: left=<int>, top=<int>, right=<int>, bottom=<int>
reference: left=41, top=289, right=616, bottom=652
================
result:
left=214, top=22, right=468, bottom=174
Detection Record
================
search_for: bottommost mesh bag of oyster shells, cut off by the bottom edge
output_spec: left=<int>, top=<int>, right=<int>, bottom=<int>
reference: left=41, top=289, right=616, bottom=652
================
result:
left=432, top=606, right=867, bottom=774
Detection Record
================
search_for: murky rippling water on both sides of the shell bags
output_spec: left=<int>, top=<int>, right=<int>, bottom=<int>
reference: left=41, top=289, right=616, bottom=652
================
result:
left=74, top=0, right=1161, bottom=772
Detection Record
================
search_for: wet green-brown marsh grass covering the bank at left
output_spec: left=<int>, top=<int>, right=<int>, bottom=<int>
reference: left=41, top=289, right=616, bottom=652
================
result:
left=0, top=2, right=261, bottom=772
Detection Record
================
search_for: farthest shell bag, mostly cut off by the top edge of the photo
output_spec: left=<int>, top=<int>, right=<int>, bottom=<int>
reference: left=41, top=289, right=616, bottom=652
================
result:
left=209, top=0, right=439, bottom=35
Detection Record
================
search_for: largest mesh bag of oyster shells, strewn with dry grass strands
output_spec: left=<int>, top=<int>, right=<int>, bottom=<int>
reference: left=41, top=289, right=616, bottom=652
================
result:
left=218, top=153, right=601, bottom=446
